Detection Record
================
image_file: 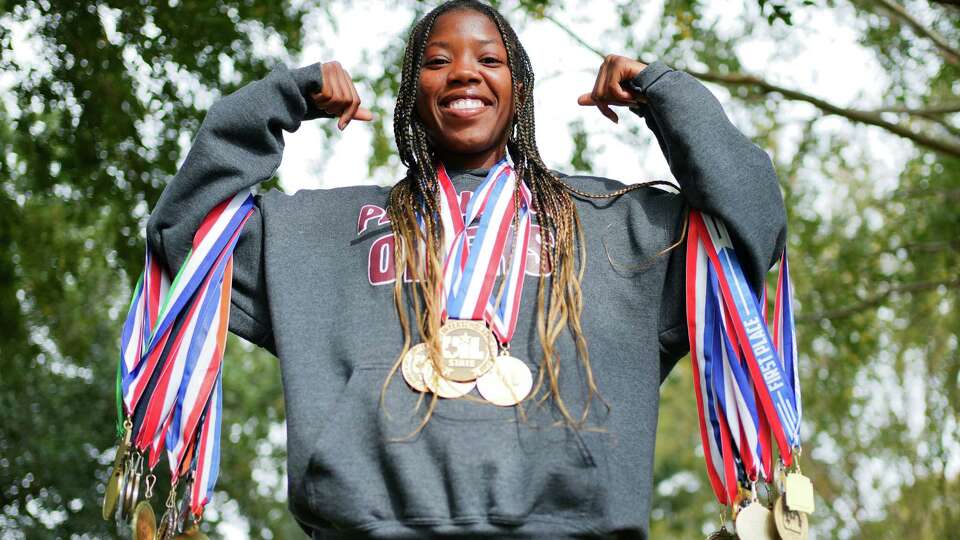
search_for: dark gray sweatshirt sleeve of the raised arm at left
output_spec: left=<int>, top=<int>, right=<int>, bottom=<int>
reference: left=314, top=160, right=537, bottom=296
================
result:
left=147, top=63, right=328, bottom=354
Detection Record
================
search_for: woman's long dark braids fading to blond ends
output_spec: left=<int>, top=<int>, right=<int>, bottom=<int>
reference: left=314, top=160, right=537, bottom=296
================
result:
left=381, top=0, right=664, bottom=436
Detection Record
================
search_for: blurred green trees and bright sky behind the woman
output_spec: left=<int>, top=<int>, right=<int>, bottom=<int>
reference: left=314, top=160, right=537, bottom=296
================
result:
left=0, top=0, right=960, bottom=540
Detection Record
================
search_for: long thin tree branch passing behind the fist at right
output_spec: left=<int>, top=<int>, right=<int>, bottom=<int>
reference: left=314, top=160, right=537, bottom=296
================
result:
left=543, top=14, right=960, bottom=157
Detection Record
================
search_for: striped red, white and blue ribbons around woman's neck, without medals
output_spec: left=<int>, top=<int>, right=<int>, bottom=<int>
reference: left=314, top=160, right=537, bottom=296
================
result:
left=437, top=158, right=532, bottom=344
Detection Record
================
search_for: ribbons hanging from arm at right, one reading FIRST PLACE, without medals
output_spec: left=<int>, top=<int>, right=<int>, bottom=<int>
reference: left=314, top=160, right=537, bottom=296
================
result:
left=686, top=211, right=800, bottom=505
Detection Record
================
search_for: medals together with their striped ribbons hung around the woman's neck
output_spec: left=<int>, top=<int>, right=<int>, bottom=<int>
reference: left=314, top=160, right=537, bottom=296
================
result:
left=432, top=158, right=532, bottom=392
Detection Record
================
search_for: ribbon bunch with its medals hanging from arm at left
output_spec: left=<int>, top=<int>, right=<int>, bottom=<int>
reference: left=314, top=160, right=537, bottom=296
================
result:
left=103, top=192, right=254, bottom=538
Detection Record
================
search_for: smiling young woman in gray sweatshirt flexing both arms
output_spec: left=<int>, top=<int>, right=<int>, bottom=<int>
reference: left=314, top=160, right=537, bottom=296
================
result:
left=147, top=0, right=785, bottom=538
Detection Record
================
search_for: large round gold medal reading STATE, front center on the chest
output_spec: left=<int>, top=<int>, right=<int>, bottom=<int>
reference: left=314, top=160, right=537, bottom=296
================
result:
left=436, top=319, right=497, bottom=386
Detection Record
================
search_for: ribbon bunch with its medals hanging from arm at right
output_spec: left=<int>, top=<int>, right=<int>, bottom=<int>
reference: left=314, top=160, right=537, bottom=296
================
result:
left=686, top=211, right=813, bottom=538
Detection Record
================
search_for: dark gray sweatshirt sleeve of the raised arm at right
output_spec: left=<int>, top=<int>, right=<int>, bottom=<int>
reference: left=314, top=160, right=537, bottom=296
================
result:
left=626, top=61, right=787, bottom=381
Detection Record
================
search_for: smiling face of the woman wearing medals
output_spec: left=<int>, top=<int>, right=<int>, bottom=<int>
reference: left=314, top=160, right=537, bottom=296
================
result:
left=416, top=10, right=513, bottom=168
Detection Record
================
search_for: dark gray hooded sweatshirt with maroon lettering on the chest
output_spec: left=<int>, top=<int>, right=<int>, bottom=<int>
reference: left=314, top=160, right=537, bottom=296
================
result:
left=147, top=62, right=786, bottom=538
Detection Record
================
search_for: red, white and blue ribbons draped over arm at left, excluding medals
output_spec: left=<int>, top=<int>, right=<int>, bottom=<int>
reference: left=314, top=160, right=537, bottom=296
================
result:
left=117, top=192, right=254, bottom=515
